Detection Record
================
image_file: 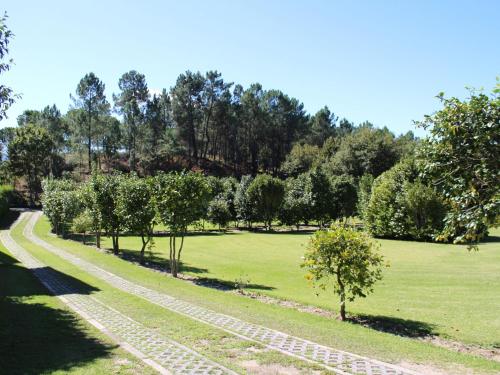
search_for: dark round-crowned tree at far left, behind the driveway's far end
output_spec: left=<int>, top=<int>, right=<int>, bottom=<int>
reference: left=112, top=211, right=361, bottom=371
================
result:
left=9, top=125, right=54, bottom=205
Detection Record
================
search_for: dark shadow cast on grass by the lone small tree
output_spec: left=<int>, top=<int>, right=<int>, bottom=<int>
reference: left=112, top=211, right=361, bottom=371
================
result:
left=349, top=315, right=435, bottom=338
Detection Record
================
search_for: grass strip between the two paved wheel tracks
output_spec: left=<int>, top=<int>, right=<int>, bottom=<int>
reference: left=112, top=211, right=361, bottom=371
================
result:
left=12, top=214, right=321, bottom=373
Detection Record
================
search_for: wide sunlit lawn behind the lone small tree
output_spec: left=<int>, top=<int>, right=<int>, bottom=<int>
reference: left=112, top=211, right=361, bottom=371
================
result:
left=104, top=225, right=500, bottom=347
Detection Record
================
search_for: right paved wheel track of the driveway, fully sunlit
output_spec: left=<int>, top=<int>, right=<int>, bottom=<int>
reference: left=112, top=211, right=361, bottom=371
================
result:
left=24, top=212, right=417, bottom=375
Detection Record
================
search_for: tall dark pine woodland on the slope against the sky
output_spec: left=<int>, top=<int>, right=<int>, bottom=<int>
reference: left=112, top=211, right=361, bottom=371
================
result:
left=1, top=71, right=414, bottom=182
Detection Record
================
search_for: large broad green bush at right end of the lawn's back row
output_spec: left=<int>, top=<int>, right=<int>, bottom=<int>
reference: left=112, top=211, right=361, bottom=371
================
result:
left=364, top=161, right=446, bottom=240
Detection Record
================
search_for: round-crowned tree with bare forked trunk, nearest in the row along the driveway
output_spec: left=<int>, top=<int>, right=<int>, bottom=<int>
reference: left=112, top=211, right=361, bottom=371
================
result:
left=154, top=172, right=210, bottom=277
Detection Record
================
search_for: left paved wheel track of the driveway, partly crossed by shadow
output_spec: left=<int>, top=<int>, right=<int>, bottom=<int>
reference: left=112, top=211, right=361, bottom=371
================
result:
left=0, top=213, right=235, bottom=375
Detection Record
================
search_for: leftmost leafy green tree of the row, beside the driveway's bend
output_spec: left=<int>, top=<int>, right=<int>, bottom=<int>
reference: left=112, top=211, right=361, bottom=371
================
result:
left=41, top=179, right=82, bottom=237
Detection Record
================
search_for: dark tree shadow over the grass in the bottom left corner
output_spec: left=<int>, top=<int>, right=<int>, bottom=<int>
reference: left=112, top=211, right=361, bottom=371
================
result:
left=0, top=248, right=114, bottom=374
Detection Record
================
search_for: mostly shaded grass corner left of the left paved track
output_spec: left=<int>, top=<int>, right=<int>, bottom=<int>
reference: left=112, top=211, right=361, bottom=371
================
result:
left=0, top=231, right=155, bottom=374
